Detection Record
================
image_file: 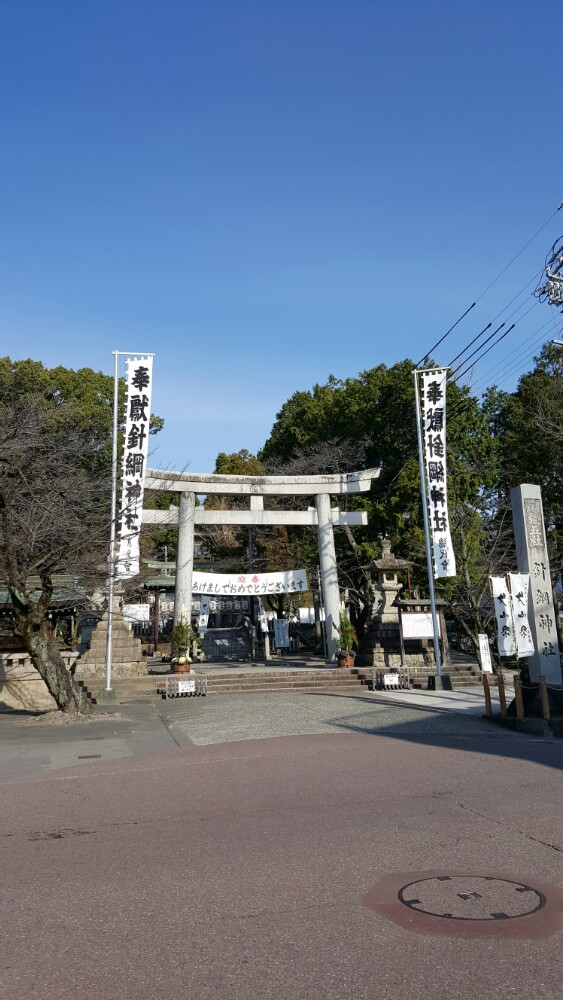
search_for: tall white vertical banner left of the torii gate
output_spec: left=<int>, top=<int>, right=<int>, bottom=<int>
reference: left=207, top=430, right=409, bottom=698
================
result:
left=116, top=357, right=153, bottom=579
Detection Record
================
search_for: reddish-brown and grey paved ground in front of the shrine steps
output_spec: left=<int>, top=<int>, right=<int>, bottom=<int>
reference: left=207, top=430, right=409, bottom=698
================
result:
left=0, top=691, right=563, bottom=1000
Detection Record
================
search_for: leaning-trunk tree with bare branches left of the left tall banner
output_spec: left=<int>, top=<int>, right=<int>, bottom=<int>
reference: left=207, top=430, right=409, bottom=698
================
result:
left=0, top=358, right=162, bottom=712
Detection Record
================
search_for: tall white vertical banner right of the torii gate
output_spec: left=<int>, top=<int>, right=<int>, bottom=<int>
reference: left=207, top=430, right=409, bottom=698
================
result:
left=420, top=369, right=456, bottom=579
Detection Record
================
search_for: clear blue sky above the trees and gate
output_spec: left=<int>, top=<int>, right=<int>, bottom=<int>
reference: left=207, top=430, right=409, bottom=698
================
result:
left=0, top=0, right=563, bottom=471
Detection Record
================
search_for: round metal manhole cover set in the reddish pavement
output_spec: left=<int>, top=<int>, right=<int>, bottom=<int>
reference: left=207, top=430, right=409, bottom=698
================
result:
left=398, top=875, right=545, bottom=920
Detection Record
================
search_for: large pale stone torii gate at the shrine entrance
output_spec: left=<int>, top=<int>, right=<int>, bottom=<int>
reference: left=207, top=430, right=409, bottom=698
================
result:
left=143, top=468, right=380, bottom=660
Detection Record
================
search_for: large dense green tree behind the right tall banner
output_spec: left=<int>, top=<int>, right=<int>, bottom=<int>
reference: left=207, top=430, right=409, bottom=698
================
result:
left=259, top=360, right=495, bottom=633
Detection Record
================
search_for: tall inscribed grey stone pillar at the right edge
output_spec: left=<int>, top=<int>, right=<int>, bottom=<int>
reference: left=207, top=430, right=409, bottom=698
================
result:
left=510, top=483, right=561, bottom=684
